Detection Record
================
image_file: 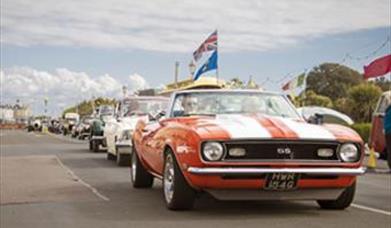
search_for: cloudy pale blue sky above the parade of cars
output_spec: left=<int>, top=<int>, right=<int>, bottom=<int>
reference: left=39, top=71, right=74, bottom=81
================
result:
left=0, top=0, right=391, bottom=115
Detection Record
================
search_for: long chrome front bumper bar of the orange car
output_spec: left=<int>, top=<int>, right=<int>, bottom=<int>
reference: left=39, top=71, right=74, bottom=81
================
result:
left=187, top=167, right=366, bottom=176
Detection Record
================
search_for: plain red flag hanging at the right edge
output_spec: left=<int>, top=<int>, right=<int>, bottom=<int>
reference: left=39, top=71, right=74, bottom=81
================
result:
left=364, top=54, right=391, bottom=79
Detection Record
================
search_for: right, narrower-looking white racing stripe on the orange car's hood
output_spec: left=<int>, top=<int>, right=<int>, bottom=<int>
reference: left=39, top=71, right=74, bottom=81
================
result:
left=279, top=118, right=335, bottom=140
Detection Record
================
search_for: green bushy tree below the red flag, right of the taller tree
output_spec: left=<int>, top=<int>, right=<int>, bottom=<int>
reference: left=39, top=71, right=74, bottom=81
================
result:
left=344, top=83, right=382, bottom=122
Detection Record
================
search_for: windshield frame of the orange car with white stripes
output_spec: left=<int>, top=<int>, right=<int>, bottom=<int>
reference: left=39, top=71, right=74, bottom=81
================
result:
left=167, top=90, right=303, bottom=120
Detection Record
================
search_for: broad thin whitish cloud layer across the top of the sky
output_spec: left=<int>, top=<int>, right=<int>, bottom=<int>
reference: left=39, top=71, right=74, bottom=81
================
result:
left=1, top=0, right=390, bottom=52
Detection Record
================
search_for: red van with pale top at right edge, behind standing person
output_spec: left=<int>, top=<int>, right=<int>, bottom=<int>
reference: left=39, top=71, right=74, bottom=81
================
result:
left=369, top=90, right=391, bottom=159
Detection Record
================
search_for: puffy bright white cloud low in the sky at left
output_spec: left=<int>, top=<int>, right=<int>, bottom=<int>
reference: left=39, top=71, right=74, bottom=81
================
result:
left=0, top=67, right=148, bottom=114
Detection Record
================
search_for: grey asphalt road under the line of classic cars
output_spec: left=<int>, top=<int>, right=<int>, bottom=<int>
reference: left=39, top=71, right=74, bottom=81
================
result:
left=0, top=130, right=391, bottom=228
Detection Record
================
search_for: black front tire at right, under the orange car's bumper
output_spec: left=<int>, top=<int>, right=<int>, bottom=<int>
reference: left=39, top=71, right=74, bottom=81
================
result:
left=317, top=182, right=356, bottom=210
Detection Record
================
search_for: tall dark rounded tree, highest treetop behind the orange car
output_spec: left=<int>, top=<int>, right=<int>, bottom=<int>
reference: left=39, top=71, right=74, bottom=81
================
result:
left=307, top=63, right=363, bottom=101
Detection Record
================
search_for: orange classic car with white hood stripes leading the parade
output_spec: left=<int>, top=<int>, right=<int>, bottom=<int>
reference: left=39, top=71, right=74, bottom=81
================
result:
left=131, top=90, right=365, bottom=210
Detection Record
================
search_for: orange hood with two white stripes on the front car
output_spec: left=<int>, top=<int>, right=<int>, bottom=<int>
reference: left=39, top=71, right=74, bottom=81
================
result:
left=179, top=114, right=362, bottom=142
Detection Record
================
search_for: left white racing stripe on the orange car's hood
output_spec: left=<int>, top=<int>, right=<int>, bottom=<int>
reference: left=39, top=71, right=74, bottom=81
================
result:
left=214, top=114, right=271, bottom=139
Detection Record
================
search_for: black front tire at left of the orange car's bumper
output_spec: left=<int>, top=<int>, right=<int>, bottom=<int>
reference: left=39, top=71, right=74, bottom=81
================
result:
left=163, top=150, right=196, bottom=210
